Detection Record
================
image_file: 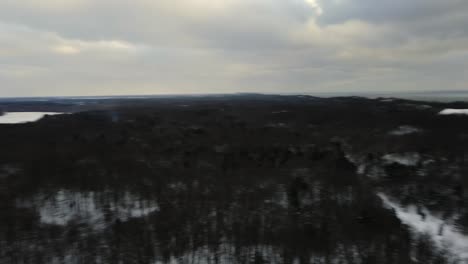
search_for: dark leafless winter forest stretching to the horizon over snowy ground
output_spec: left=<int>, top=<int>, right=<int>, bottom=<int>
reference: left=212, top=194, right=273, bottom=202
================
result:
left=0, top=95, right=468, bottom=264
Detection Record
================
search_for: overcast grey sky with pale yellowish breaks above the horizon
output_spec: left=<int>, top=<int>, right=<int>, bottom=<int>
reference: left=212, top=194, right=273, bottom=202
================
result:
left=0, top=0, right=468, bottom=97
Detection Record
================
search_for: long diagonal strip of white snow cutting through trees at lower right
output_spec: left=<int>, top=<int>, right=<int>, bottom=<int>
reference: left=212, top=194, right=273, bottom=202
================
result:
left=378, top=193, right=468, bottom=263
